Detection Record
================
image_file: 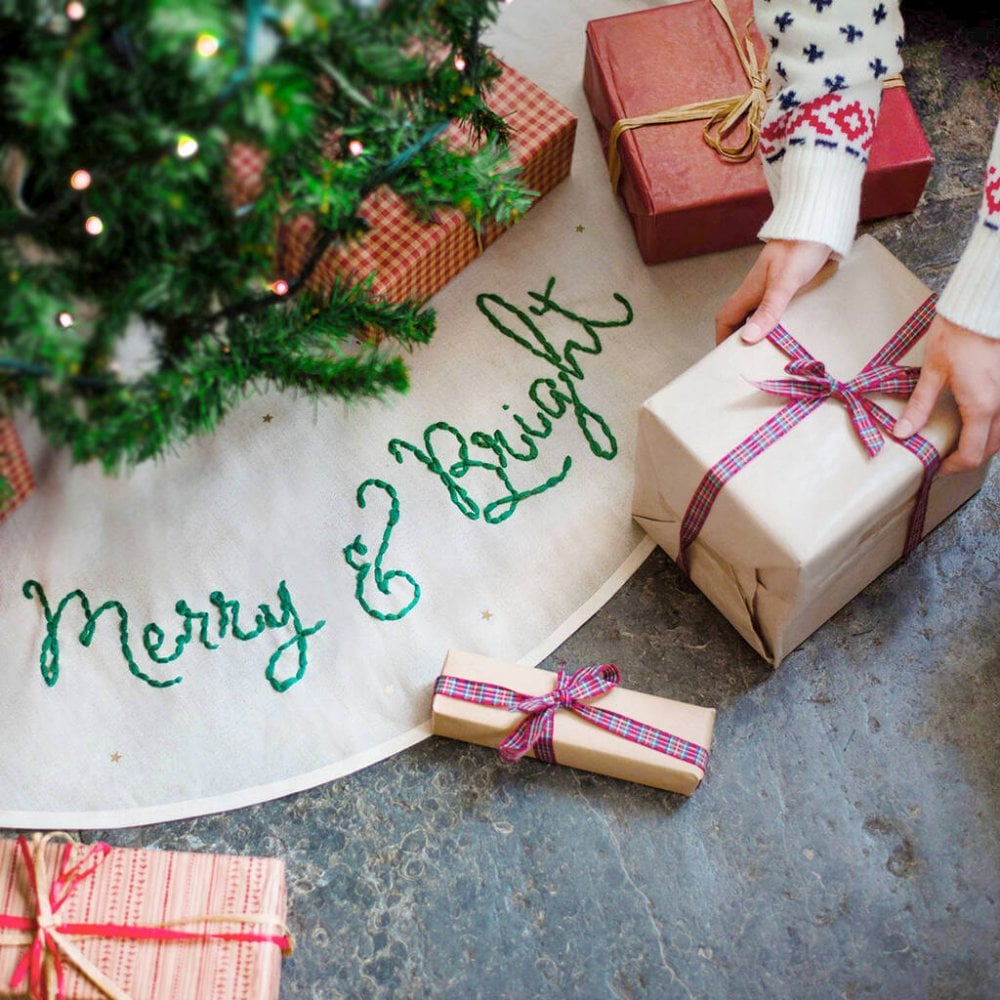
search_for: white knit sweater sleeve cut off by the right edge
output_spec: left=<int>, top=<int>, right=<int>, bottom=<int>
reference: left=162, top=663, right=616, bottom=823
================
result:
left=937, top=121, right=1000, bottom=340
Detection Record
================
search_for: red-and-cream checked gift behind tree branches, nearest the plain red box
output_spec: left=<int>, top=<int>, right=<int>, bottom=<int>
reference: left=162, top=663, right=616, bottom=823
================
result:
left=226, top=63, right=576, bottom=301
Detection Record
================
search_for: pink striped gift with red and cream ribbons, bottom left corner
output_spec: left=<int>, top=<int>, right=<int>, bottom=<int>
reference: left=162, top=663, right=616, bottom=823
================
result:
left=0, top=834, right=292, bottom=1000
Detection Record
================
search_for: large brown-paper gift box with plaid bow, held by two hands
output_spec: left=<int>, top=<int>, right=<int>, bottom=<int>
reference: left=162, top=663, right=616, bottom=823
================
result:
left=632, top=236, right=985, bottom=665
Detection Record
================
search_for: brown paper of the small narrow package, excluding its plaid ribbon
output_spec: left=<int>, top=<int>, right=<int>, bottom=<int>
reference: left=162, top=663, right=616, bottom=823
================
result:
left=431, top=650, right=715, bottom=795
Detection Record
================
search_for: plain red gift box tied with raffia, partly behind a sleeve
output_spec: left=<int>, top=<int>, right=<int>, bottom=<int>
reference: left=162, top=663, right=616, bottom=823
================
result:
left=583, top=0, right=933, bottom=264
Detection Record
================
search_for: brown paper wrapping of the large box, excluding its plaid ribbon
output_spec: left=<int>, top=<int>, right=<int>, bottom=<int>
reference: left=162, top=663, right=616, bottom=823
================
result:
left=632, top=236, right=985, bottom=666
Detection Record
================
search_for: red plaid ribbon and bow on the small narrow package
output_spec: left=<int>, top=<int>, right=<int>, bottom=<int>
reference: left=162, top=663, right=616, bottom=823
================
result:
left=434, top=663, right=708, bottom=772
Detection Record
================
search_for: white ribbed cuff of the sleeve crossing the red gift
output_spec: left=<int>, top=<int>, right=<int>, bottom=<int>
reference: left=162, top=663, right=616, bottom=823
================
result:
left=757, top=146, right=865, bottom=257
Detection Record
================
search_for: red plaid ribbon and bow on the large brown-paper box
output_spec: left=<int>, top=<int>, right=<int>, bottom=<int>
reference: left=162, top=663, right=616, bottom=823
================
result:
left=677, top=294, right=941, bottom=573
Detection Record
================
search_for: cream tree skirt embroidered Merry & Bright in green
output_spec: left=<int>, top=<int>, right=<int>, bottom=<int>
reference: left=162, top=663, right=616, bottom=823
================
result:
left=0, top=0, right=755, bottom=829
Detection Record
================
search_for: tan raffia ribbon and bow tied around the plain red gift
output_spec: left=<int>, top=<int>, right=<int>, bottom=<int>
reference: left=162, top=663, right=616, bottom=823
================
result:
left=608, top=0, right=903, bottom=191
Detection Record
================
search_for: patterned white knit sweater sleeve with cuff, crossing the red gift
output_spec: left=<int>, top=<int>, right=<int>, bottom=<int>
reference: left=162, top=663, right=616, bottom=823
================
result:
left=754, top=0, right=903, bottom=256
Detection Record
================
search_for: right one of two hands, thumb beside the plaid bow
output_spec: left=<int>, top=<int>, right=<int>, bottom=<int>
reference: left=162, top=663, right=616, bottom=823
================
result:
left=893, top=316, right=1000, bottom=474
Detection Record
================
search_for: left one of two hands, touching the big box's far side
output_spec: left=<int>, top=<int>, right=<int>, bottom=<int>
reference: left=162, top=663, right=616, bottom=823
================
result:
left=715, top=240, right=831, bottom=344
